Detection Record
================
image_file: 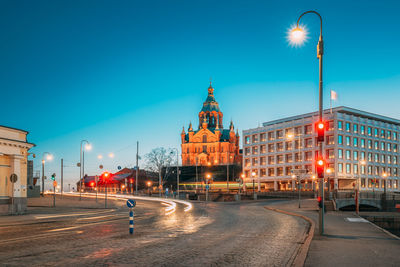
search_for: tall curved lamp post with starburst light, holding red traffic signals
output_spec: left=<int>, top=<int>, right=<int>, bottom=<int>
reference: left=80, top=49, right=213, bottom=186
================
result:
left=290, top=10, right=324, bottom=235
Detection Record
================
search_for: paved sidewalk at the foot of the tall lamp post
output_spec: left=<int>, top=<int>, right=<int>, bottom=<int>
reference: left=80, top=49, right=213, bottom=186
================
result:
left=268, top=200, right=400, bottom=267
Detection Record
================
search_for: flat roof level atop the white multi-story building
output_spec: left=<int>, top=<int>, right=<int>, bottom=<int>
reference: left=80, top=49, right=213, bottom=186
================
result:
left=263, top=106, right=400, bottom=127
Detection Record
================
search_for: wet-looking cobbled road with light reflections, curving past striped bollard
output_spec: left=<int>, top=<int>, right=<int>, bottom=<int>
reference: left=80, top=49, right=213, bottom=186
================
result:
left=0, top=196, right=308, bottom=266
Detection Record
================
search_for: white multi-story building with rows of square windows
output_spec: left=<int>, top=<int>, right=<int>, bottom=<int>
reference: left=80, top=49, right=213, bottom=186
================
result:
left=243, top=107, right=400, bottom=191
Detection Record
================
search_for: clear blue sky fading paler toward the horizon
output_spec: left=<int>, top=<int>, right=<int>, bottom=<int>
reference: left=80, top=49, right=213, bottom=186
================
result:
left=0, top=0, right=400, bottom=191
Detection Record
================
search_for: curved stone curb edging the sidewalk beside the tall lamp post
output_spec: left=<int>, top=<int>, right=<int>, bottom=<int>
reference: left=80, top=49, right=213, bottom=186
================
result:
left=264, top=207, right=315, bottom=267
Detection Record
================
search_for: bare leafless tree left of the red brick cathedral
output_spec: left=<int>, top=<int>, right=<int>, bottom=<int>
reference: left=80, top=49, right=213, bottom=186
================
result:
left=145, top=147, right=175, bottom=196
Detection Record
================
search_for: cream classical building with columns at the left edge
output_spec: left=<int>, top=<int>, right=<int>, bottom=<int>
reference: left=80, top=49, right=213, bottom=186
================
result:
left=0, top=126, right=34, bottom=214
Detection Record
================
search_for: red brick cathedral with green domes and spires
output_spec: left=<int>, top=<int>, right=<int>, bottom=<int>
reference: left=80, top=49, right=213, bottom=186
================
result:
left=181, top=82, right=241, bottom=166
